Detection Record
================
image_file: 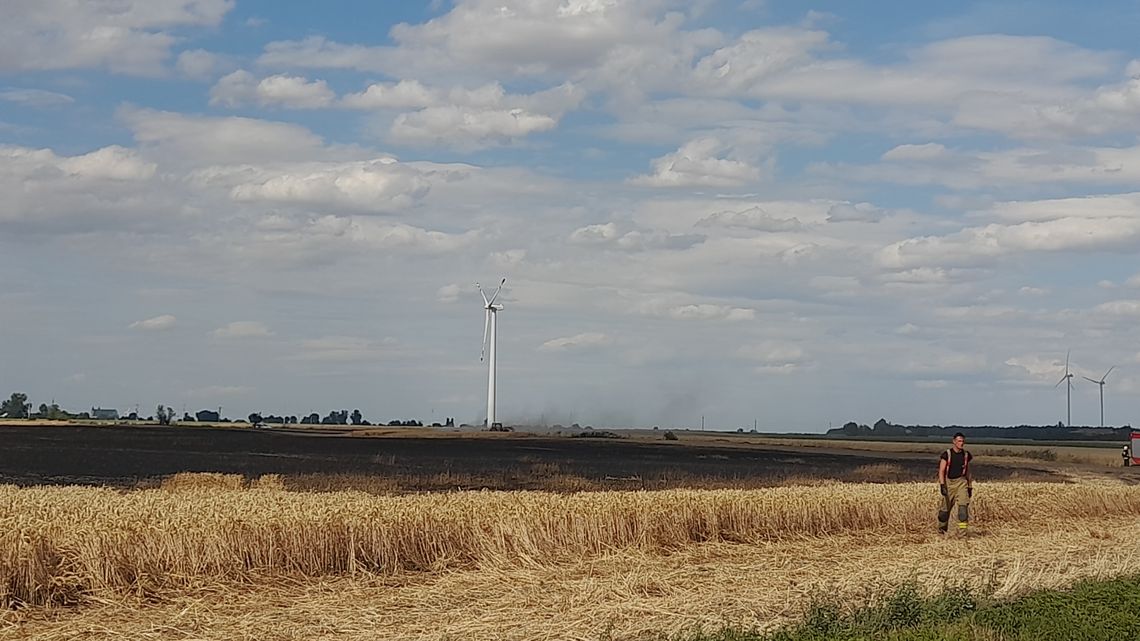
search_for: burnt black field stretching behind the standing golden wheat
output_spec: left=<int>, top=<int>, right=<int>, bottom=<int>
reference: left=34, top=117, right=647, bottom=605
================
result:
left=0, top=424, right=1061, bottom=490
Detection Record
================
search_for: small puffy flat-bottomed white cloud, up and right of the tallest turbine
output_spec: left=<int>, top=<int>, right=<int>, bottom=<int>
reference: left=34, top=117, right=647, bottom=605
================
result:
left=629, top=137, right=762, bottom=187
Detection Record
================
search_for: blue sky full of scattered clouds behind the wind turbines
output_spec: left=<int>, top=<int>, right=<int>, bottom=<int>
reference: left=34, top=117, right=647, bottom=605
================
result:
left=0, top=0, right=1140, bottom=432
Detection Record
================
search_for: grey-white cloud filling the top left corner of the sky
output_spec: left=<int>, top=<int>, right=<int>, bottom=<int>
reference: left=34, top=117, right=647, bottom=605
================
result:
left=0, top=0, right=234, bottom=74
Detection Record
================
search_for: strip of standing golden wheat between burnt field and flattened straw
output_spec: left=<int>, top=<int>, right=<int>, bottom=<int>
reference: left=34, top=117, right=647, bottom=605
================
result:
left=0, top=476, right=1140, bottom=607
